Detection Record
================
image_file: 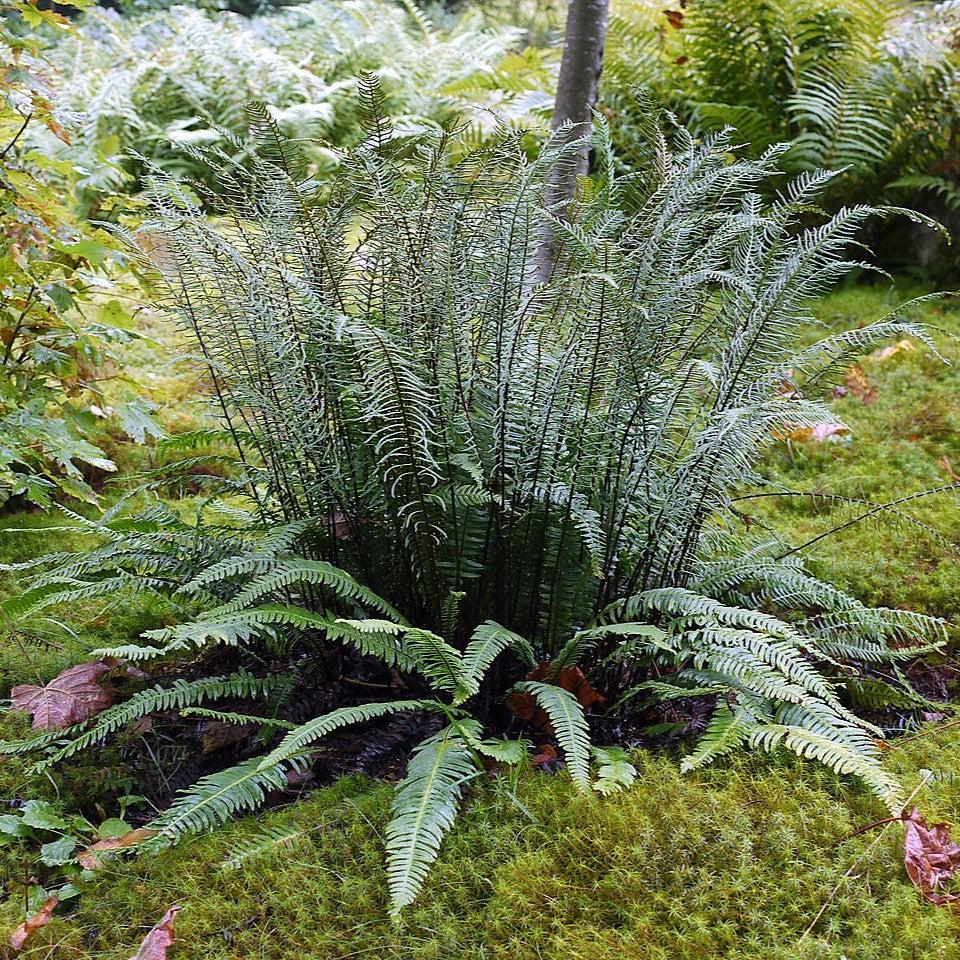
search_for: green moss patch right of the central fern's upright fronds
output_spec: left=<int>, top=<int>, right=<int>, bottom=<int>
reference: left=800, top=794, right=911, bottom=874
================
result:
left=745, top=286, right=960, bottom=620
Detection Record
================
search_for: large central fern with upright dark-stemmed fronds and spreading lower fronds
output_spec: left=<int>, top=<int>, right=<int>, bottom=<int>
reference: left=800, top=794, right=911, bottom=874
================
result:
left=6, top=99, right=942, bottom=910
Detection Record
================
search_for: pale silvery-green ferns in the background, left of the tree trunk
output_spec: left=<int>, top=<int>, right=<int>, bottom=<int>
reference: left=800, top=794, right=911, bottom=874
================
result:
left=50, top=0, right=550, bottom=201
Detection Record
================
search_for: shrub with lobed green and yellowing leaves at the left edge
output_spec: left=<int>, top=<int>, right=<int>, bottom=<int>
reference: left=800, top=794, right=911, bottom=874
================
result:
left=0, top=4, right=160, bottom=505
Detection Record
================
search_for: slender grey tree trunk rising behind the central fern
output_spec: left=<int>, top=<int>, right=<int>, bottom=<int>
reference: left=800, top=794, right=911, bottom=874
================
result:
left=537, top=0, right=610, bottom=281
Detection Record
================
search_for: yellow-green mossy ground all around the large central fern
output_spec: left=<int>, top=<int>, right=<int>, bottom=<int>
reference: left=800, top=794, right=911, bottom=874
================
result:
left=0, top=286, right=960, bottom=960
